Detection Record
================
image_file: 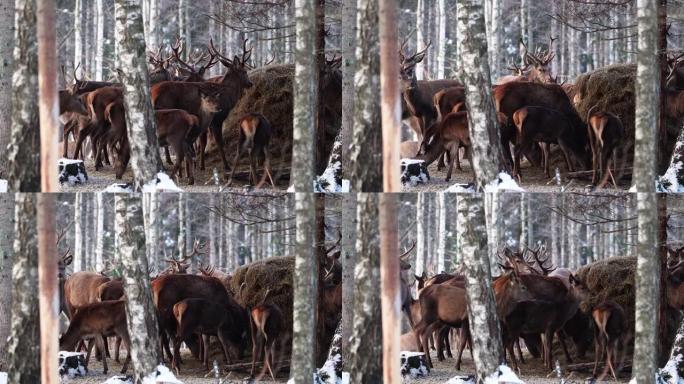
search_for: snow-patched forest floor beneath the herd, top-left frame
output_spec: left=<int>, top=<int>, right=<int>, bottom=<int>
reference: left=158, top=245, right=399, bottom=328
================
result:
left=60, top=141, right=288, bottom=193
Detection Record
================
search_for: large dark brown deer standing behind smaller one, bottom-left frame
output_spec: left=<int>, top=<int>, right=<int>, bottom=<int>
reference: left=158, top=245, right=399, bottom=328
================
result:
left=152, top=274, right=249, bottom=364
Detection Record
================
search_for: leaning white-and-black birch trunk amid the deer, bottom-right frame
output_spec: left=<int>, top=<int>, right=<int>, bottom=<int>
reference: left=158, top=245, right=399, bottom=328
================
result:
left=458, top=194, right=503, bottom=382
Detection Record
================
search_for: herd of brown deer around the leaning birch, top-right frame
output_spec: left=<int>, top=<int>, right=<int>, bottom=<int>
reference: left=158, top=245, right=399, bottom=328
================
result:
left=406, top=38, right=684, bottom=187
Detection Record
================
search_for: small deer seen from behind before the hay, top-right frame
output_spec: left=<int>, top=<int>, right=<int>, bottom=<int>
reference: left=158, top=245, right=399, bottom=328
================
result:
left=587, top=105, right=625, bottom=188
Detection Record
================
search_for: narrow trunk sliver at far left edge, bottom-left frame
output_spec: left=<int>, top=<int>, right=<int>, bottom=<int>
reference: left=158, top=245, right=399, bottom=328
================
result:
left=0, top=194, right=14, bottom=371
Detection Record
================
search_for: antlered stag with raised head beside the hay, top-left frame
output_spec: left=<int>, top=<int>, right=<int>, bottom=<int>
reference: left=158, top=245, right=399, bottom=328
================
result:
left=152, top=40, right=252, bottom=178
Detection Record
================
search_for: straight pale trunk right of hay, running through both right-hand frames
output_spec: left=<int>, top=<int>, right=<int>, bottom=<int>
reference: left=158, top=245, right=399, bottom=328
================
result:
left=632, top=0, right=660, bottom=383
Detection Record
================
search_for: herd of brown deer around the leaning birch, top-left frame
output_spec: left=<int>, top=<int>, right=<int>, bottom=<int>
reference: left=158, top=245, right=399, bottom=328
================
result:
left=59, top=39, right=275, bottom=186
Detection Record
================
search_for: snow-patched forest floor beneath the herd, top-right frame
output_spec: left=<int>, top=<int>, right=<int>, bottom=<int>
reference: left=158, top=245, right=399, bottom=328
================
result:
left=402, top=152, right=630, bottom=193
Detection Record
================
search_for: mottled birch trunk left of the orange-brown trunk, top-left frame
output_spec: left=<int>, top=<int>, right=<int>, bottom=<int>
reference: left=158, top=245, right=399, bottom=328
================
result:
left=7, top=0, right=40, bottom=192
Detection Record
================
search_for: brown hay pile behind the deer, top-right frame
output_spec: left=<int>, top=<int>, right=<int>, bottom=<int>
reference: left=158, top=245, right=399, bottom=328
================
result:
left=573, top=64, right=636, bottom=174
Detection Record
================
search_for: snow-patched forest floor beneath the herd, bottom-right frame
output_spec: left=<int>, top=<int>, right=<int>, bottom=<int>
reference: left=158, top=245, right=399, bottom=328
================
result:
left=404, top=349, right=630, bottom=384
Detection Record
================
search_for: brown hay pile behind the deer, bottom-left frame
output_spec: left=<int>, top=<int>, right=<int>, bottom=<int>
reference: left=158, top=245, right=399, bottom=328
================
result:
left=230, top=256, right=294, bottom=342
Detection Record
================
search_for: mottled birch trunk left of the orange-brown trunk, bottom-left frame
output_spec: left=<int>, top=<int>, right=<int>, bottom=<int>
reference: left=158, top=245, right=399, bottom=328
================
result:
left=7, top=193, right=39, bottom=384
